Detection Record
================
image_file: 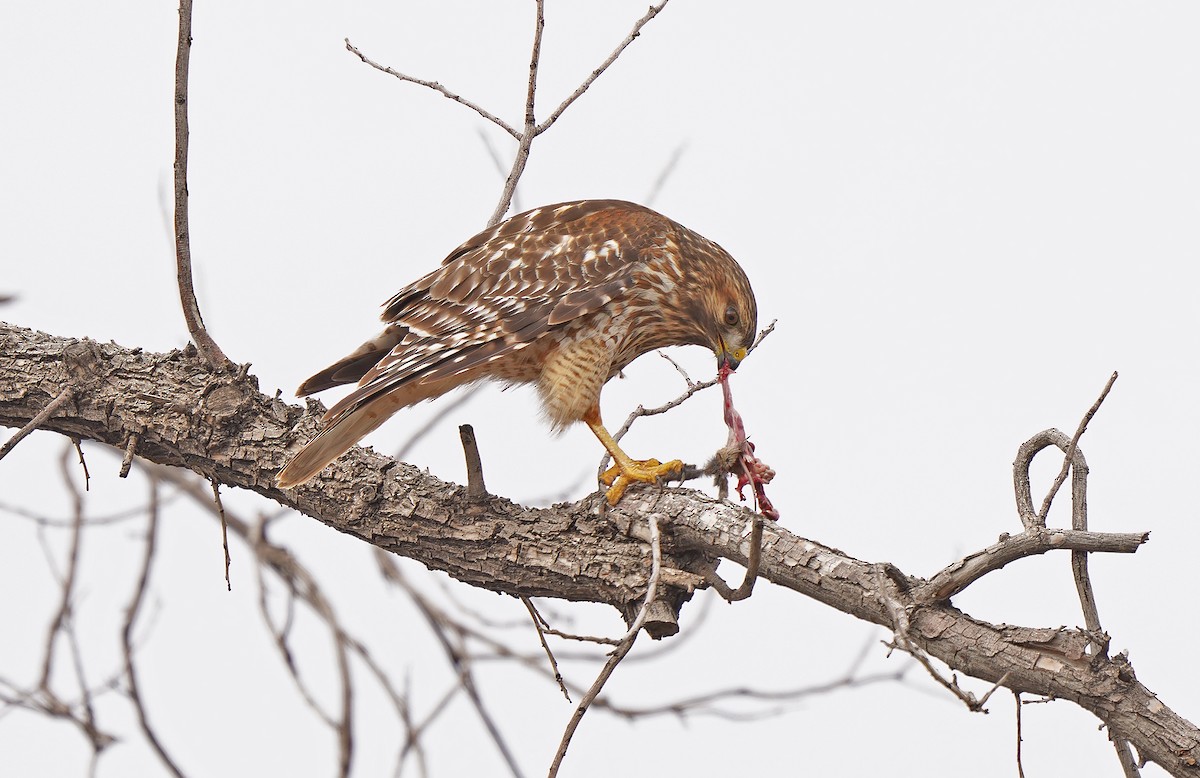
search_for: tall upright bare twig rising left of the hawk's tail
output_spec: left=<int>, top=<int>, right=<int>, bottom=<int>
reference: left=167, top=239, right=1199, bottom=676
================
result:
left=175, top=0, right=233, bottom=370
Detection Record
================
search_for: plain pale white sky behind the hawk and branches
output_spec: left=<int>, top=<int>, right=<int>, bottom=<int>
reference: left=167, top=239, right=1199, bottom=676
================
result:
left=0, top=0, right=1200, bottom=776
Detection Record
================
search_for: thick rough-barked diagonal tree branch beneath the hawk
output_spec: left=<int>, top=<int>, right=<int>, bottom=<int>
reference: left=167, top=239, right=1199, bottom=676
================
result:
left=0, top=323, right=1200, bottom=776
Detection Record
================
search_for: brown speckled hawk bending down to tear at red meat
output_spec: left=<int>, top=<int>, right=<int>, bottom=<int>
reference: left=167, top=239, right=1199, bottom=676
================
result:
left=277, top=199, right=757, bottom=504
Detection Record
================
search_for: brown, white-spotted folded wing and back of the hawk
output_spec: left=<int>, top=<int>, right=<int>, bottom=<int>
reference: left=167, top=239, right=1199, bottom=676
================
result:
left=316, top=201, right=671, bottom=424
